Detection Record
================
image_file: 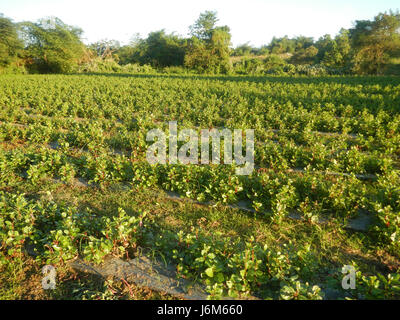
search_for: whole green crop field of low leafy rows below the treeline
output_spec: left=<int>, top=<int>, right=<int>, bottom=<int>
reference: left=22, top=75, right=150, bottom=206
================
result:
left=0, top=74, right=400, bottom=299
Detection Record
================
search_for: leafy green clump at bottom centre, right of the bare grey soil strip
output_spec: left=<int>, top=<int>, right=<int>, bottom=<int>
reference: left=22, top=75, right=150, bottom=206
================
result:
left=156, top=232, right=322, bottom=300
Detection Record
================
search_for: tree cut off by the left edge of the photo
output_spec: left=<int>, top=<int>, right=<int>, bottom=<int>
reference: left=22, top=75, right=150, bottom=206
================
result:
left=0, top=14, right=22, bottom=67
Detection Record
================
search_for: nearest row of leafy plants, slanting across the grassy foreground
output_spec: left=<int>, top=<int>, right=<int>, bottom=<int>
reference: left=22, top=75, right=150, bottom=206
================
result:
left=0, top=192, right=400, bottom=299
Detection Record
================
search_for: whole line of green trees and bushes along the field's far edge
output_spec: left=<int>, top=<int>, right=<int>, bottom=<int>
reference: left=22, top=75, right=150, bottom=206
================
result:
left=0, top=11, right=400, bottom=75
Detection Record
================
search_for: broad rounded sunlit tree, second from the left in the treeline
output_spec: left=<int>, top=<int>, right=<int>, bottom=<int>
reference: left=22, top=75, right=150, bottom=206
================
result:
left=21, top=18, right=85, bottom=73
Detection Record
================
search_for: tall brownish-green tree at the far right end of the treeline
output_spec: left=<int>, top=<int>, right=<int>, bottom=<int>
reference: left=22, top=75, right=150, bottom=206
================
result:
left=350, top=11, right=400, bottom=74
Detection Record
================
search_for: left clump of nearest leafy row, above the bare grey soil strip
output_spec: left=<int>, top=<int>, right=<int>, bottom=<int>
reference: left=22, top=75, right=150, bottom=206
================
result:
left=0, top=193, right=146, bottom=263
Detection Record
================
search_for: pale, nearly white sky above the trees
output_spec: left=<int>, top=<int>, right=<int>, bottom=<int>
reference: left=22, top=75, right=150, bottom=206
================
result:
left=0, top=0, right=400, bottom=46
